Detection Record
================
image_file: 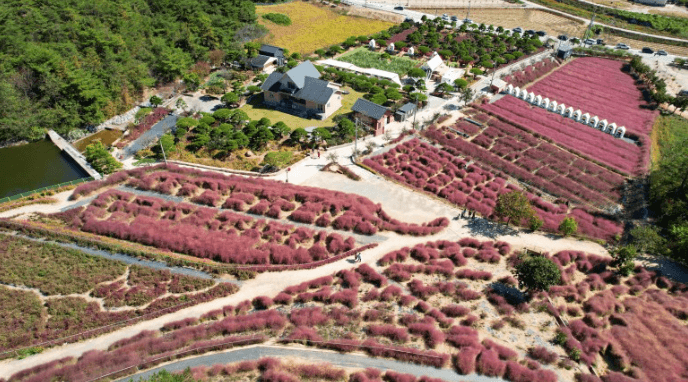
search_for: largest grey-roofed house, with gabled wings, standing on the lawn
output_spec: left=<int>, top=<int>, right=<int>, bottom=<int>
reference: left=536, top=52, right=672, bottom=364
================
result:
left=261, top=61, right=342, bottom=119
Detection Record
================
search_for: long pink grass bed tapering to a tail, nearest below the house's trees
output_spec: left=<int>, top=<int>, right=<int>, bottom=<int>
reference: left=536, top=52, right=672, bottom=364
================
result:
left=68, top=166, right=449, bottom=236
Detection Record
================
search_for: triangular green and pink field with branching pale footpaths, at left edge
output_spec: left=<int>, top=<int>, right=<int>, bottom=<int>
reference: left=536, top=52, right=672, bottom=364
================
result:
left=0, top=235, right=238, bottom=350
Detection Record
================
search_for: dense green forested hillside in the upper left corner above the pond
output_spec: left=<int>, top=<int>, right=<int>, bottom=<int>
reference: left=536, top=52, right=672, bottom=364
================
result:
left=0, top=0, right=256, bottom=143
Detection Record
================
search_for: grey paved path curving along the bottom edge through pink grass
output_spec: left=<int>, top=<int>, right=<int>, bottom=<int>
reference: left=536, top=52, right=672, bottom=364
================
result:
left=118, top=346, right=504, bottom=382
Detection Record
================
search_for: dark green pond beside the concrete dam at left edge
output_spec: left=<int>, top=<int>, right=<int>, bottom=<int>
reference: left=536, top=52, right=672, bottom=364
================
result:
left=0, top=139, right=88, bottom=198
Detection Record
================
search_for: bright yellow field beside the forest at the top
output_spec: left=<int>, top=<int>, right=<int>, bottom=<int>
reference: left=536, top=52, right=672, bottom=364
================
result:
left=256, top=1, right=394, bottom=54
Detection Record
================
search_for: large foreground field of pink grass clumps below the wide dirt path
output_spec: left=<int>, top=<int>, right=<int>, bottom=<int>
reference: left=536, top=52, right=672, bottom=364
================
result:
left=11, top=238, right=688, bottom=382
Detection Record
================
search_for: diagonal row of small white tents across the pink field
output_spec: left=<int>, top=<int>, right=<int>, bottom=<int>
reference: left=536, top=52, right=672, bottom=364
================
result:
left=506, top=84, right=626, bottom=138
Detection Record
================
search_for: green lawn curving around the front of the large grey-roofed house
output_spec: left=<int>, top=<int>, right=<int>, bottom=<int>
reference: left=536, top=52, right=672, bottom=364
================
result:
left=241, top=87, right=365, bottom=130
